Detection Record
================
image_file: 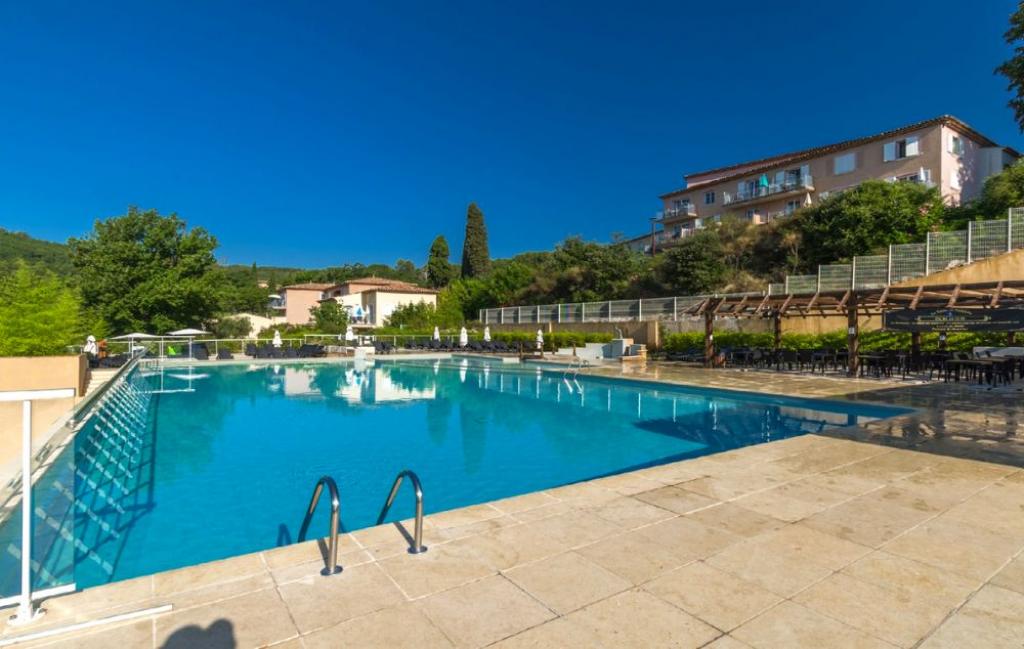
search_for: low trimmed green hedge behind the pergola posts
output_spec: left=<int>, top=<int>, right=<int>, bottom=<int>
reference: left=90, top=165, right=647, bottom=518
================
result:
left=663, top=331, right=1007, bottom=351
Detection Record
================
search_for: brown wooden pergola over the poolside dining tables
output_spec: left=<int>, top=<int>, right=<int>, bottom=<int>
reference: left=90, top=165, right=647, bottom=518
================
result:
left=684, top=279, right=1024, bottom=376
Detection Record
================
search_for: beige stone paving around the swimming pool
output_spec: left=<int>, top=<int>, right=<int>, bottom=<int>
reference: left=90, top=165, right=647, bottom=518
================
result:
left=0, top=363, right=1024, bottom=649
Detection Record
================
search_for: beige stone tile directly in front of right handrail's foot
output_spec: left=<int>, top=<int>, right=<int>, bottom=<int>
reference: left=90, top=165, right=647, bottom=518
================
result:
left=377, top=539, right=495, bottom=599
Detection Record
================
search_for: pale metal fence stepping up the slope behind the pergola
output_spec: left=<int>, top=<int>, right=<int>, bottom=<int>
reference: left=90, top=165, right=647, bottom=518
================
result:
left=480, top=208, right=1024, bottom=325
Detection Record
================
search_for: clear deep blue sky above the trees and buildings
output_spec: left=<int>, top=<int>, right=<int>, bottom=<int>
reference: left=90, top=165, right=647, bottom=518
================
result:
left=0, top=0, right=1024, bottom=266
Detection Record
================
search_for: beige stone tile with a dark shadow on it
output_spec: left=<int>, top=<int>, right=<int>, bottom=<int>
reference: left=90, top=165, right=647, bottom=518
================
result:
left=155, top=585, right=298, bottom=647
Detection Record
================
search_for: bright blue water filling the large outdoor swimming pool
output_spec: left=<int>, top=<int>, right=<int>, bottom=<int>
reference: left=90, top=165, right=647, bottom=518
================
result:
left=0, top=359, right=905, bottom=594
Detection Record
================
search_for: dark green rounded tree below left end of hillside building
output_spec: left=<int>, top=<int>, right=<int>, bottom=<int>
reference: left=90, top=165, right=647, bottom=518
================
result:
left=656, top=229, right=728, bottom=295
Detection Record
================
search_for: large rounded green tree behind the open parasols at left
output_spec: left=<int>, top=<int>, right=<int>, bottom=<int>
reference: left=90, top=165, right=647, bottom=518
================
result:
left=69, top=207, right=223, bottom=333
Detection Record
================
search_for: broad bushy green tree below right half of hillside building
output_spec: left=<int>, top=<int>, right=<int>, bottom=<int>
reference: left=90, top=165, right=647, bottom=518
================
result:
left=793, top=180, right=943, bottom=270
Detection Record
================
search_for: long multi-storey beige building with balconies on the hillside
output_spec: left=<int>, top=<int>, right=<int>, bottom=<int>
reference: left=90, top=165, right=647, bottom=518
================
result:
left=647, top=116, right=1019, bottom=250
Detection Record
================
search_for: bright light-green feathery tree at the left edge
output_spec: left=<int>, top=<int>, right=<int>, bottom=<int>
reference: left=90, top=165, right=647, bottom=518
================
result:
left=0, top=261, right=85, bottom=356
